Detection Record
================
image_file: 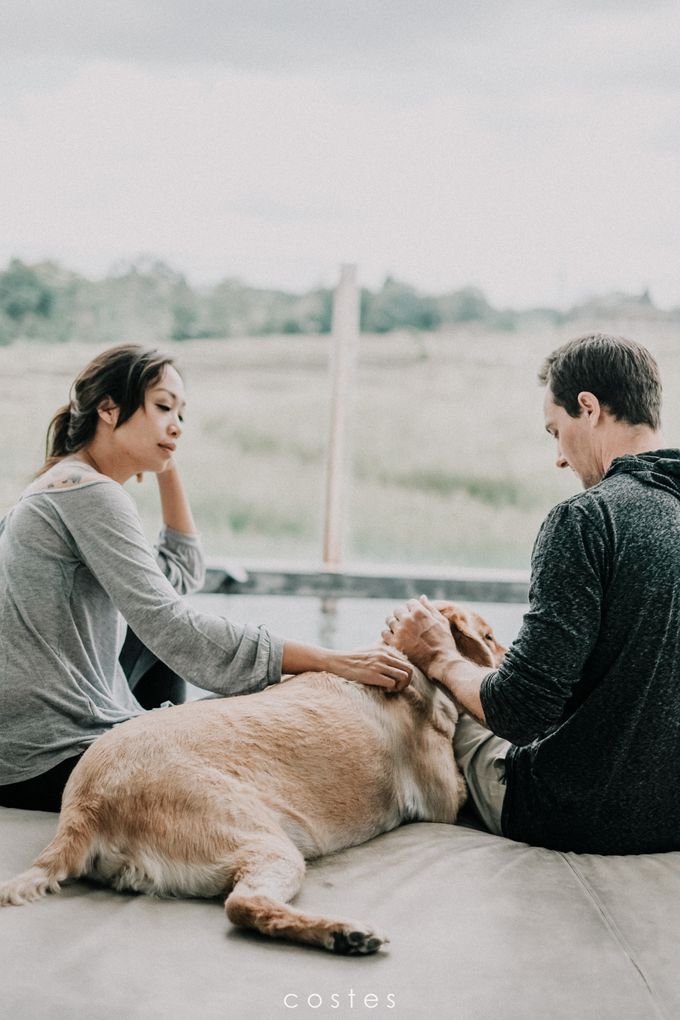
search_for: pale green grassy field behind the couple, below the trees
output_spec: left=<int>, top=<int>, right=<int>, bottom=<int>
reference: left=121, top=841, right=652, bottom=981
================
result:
left=0, top=322, right=680, bottom=568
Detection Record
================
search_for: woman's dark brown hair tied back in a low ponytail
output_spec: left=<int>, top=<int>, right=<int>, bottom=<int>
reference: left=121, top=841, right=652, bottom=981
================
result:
left=38, top=344, right=174, bottom=475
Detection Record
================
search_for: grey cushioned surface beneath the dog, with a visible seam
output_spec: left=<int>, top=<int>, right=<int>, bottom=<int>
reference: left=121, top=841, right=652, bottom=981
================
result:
left=0, top=809, right=680, bottom=1020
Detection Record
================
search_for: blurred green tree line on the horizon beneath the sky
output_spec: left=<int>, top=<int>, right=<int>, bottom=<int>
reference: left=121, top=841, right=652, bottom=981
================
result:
left=0, top=258, right=668, bottom=344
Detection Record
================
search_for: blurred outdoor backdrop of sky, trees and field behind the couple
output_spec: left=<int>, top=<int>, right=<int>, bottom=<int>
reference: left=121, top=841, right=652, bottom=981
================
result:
left=0, top=0, right=680, bottom=570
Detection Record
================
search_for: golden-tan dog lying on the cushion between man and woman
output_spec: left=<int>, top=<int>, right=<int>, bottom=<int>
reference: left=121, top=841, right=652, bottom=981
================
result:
left=0, top=602, right=506, bottom=954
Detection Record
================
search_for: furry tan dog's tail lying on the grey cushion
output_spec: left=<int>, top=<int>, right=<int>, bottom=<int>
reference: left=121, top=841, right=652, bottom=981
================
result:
left=0, top=807, right=95, bottom=907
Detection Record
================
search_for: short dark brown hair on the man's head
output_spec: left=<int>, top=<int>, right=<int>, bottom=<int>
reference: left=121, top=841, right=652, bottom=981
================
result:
left=538, top=333, right=662, bottom=430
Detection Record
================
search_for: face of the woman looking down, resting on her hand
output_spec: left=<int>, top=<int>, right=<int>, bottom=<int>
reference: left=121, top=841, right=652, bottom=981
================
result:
left=112, top=365, right=186, bottom=474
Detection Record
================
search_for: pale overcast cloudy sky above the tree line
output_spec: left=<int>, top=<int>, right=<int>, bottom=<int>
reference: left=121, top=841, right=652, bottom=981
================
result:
left=0, top=0, right=680, bottom=306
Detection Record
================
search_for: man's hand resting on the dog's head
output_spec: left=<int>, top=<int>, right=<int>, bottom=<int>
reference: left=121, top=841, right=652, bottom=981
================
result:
left=382, top=595, right=462, bottom=680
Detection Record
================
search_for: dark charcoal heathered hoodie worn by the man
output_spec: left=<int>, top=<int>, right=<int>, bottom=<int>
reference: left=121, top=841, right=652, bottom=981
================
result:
left=481, top=450, right=680, bottom=854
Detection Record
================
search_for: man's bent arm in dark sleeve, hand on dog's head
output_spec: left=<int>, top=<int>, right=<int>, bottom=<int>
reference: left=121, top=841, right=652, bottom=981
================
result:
left=383, top=501, right=611, bottom=745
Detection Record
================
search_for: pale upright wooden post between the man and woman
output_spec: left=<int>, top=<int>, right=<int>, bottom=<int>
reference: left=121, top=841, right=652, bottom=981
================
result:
left=323, top=265, right=359, bottom=570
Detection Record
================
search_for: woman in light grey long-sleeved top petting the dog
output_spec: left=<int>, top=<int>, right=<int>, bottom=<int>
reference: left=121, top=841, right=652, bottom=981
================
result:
left=0, top=345, right=410, bottom=811
